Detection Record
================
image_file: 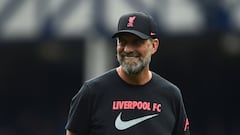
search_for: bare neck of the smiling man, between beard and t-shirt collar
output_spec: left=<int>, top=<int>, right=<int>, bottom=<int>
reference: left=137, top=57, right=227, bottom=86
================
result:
left=117, top=66, right=152, bottom=85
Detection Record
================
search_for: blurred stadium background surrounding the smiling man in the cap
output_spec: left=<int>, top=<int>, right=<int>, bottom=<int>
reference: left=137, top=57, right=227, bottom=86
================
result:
left=0, top=0, right=240, bottom=135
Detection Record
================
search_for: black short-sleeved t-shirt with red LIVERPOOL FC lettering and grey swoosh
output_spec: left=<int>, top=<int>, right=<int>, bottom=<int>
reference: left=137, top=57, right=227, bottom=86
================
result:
left=66, top=69, right=190, bottom=135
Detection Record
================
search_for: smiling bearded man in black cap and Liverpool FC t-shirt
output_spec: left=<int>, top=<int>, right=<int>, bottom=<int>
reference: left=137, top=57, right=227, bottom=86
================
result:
left=66, top=12, right=190, bottom=135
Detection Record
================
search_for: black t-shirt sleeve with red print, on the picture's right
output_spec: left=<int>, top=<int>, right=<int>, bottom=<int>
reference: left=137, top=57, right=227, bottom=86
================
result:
left=173, top=90, right=190, bottom=135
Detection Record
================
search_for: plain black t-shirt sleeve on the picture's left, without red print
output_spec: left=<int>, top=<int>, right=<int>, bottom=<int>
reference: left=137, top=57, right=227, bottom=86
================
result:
left=65, top=84, right=91, bottom=135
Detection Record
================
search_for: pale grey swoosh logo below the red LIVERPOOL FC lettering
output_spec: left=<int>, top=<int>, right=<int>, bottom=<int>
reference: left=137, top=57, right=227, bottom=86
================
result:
left=115, top=112, right=158, bottom=130
